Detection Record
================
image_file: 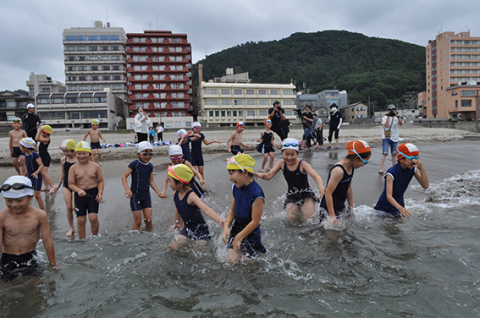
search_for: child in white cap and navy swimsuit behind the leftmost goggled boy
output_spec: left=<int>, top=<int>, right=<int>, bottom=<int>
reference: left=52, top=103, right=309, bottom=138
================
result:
left=20, top=138, right=45, bottom=210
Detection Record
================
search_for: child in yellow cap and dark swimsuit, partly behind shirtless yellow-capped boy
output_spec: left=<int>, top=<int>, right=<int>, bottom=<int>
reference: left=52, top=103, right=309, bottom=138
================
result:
left=54, top=139, right=77, bottom=237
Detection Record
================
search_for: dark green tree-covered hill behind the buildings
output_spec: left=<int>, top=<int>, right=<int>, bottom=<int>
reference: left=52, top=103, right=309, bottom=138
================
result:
left=193, top=31, right=425, bottom=109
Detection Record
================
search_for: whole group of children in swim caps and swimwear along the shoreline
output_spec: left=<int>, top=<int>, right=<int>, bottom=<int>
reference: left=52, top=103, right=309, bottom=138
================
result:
left=0, top=120, right=429, bottom=277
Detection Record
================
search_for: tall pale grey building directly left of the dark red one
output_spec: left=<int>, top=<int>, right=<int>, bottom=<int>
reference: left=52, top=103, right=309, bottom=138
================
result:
left=63, top=21, right=127, bottom=104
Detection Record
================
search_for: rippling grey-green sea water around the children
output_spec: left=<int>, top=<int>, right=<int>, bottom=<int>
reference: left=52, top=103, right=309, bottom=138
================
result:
left=0, top=143, right=480, bottom=317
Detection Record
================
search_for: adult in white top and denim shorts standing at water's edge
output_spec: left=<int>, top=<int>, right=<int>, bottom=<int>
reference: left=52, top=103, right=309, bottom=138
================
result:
left=378, top=104, right=403, bottom=174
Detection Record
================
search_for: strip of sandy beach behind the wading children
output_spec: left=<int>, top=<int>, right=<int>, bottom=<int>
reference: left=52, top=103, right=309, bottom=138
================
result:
left=0, top=124, right=472, bottom=166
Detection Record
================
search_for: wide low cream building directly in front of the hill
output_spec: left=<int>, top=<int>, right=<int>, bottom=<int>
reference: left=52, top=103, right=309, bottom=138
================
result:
left=198, top=69, right=296, bottom=127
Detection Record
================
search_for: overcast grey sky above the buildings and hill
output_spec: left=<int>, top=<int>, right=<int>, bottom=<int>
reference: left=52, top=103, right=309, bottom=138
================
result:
left=0, top=0, right=480, bottom=91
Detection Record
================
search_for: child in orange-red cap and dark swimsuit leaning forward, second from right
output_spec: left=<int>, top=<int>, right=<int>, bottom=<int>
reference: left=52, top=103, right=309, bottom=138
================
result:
left=320, top=140, right=372, bottom=225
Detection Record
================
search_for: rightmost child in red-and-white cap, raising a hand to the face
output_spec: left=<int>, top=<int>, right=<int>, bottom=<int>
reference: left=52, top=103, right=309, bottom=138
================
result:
left=375, top=143, right=429, bottom=218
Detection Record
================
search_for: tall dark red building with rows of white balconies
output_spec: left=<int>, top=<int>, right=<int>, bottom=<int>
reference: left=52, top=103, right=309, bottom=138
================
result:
left=127, top=31, right=193, bottom=120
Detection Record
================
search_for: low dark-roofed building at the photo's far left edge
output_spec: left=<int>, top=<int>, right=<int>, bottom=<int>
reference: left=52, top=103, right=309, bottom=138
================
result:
left=0, top=91, right=35, bottom=125
